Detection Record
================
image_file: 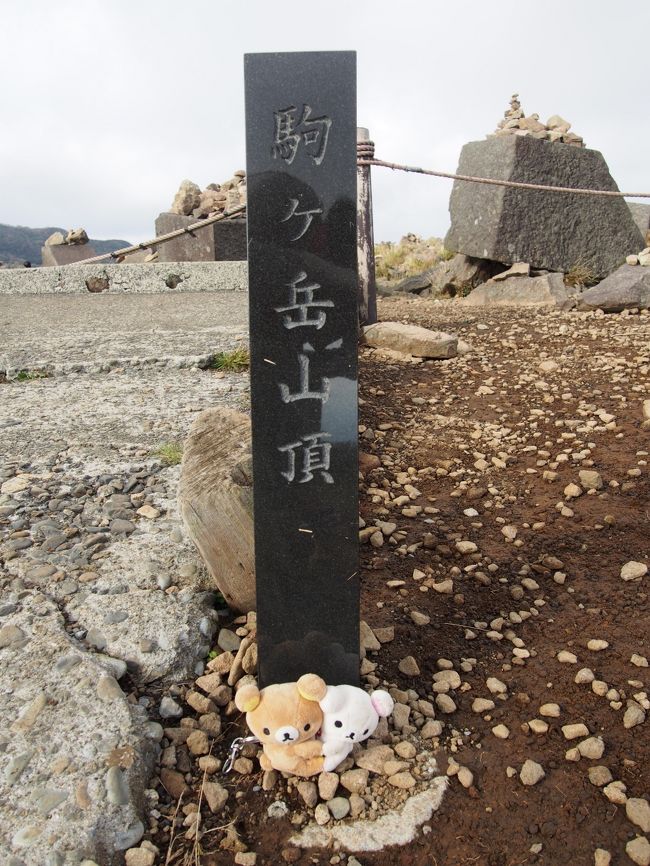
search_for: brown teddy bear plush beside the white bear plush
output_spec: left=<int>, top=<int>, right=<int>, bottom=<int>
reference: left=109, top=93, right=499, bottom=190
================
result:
left=235, top=674, right=327, bottom=777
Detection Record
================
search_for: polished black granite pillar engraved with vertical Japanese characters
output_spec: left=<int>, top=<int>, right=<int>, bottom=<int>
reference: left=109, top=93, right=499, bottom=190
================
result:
left=245, top=52, right=359, bottom=685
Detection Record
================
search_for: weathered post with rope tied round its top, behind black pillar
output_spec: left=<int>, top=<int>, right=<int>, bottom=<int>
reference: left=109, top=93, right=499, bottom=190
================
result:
left=357, top=127, right=377, bottom=325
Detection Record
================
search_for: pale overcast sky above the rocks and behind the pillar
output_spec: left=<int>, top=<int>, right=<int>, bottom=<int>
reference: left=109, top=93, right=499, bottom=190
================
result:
left=0, top=0, right=650, bottom=241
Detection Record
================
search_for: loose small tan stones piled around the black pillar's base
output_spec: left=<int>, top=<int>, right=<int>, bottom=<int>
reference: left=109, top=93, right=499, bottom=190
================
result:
left=140, top=612, right=448, bottom=864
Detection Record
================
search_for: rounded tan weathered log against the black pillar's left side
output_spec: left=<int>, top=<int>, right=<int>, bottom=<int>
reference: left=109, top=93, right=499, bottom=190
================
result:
left=178, top=408, right=255, bottom=613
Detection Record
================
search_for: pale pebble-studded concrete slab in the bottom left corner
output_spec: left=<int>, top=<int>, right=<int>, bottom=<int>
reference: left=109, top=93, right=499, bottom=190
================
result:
left=0, top=596, right=155, bottom=866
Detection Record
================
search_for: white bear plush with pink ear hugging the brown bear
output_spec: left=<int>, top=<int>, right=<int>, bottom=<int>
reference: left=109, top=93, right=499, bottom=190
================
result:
left=319, top=686, right=395, bottom=772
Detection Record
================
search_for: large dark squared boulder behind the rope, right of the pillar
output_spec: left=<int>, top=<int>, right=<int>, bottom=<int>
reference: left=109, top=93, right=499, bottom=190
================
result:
left=445, top=135, right=645, bottom=277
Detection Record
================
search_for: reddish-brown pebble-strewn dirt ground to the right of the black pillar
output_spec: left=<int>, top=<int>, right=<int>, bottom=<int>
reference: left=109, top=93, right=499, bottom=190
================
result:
left=148, top=298, right=650, bottom=866
